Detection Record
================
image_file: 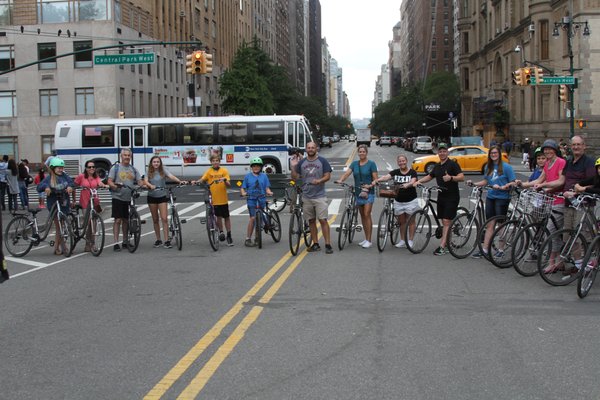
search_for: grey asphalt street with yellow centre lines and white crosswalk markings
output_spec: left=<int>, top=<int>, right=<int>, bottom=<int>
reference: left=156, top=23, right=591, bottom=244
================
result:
left=0, top=141, right=600, bottom=400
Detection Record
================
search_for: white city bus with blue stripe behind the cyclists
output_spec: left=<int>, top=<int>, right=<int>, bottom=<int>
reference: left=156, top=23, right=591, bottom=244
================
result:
left=54, top=115, right=313, bottom=178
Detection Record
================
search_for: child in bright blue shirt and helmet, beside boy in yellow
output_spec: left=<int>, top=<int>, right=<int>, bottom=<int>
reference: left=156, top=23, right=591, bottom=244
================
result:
left=241, top=157, right=273, bottom=247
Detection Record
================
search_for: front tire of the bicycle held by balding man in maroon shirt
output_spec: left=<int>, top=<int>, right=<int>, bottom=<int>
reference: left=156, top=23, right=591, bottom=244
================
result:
left=537, top=229, right=588, bottom=286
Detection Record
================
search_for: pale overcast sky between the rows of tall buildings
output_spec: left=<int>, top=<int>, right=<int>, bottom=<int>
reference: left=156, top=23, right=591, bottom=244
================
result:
left=321, top=0, right=400, bottom=119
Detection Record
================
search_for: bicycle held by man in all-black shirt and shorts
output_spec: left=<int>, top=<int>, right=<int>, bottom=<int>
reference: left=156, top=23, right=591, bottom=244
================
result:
left=405, top=184, right=469, bottom=254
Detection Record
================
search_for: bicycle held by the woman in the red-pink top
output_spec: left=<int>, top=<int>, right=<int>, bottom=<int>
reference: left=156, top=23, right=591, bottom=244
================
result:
left=70, top=187, right=105, bottom=257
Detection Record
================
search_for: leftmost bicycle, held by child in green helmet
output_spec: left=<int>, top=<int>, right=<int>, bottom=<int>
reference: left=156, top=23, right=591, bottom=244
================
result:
left=4, top=189, right=74, bottom=257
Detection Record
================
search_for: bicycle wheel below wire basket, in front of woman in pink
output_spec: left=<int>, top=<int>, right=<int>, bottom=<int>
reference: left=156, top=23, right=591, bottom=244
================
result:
left=511, top=223, right=550, bottom=276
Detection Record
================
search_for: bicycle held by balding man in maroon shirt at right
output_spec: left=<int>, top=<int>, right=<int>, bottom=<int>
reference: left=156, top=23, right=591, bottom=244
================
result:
left=535, top=194, right=600, bottom=286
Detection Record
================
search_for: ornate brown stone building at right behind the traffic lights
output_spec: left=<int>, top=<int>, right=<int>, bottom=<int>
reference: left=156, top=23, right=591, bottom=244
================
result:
left=458, top=0, right=600, bottom=145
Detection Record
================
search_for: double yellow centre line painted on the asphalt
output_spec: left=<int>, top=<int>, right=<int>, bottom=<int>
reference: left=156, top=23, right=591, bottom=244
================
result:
left=144, top=215, right=337, bottom=400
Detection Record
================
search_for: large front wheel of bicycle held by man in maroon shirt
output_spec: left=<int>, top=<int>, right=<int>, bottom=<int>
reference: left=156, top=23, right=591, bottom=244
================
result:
left=537, top=229, right=588, bottom=286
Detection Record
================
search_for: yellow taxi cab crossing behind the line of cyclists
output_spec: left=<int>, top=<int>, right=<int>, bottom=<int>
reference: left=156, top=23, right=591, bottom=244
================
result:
left=412, top=146, right=510, bottom=174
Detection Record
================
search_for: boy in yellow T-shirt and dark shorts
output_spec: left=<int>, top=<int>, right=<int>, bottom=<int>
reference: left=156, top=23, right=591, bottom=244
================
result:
left=192, top=153, right=233, bottom=246
